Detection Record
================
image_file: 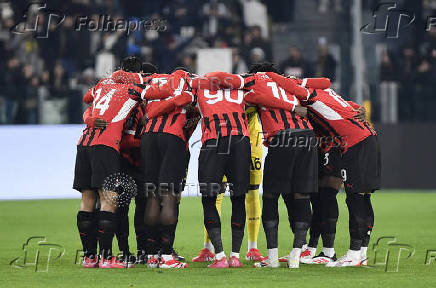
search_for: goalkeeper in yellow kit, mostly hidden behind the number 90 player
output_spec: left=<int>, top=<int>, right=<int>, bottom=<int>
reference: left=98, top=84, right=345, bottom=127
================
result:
left=192, top=107, right=263, bottom=262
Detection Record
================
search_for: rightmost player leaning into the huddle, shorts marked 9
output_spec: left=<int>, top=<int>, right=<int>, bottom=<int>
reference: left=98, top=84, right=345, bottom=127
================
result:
left=268, top=73, right=381, bottom=267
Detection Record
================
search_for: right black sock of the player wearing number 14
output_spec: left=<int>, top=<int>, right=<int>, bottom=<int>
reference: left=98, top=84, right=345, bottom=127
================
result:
left=98, top=211, right=117, bottom=259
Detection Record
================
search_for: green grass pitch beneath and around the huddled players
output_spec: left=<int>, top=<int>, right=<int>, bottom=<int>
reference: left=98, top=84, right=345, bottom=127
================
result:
left=0, top=192, right=436, bottom=287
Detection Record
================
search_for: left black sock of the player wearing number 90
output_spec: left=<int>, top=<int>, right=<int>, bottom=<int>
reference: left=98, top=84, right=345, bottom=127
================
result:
left=202, top=196, right=223, bottom=253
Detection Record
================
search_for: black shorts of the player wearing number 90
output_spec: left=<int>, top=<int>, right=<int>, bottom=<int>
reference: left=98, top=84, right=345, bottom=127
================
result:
left=198, top=136, right=251, bottom=196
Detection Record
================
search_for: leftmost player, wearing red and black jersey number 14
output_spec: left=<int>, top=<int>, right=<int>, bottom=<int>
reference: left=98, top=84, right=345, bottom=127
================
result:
left=73, top=57, right=142, bottom=268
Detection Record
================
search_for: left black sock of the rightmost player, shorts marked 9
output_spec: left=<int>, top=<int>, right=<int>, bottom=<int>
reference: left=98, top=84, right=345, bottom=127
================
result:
left=346, top=194, right=367, bottom=251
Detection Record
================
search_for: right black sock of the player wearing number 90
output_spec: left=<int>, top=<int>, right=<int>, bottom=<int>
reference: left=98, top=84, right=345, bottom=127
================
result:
left=230, top=194, right=246, bottom=253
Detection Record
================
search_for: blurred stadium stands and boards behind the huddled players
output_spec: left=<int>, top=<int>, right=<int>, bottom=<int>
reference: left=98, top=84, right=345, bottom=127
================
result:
left=0, top=0, right=436, bottom=198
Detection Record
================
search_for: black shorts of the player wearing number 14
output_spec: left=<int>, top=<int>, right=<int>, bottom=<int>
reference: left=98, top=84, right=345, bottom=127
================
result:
left=73, top=145, right=121, bottom=192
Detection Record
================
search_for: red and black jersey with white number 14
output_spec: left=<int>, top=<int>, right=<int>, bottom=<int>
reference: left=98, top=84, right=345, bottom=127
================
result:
left=78, top=78, right=142, bottom=151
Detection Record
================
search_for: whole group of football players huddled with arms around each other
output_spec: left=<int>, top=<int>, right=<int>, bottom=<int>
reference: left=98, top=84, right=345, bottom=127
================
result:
left=73, top=57, right=380, bottom=268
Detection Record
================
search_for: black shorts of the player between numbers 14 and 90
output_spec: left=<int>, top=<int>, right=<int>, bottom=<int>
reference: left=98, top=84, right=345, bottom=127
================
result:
left=141, top=132, right=188, bottom=193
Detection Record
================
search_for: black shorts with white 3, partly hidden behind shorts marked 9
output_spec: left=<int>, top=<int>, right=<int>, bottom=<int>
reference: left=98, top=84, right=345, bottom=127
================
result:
left=318, top=147, right=342, bottom=179
